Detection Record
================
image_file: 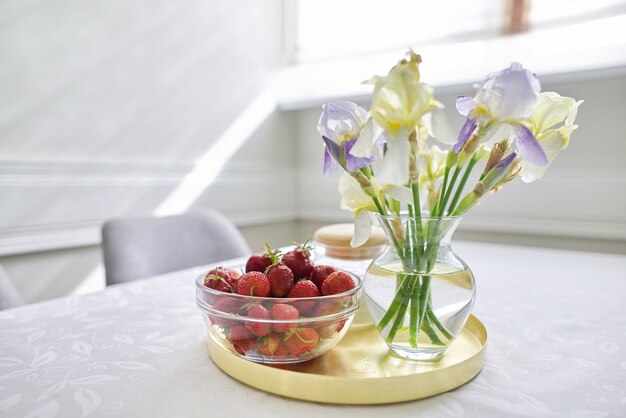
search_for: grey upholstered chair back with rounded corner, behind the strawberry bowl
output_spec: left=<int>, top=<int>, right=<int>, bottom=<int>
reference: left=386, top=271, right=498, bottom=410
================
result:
left=102, top=211, right=250, bottom=286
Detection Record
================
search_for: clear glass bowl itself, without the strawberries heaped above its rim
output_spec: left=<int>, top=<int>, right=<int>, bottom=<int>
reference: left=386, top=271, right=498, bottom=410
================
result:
left=196, top=272, right=363, bottom=364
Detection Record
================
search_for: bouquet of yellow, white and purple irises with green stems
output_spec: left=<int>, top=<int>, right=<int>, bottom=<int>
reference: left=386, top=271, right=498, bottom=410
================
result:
left=318, top=51, right=582, bottom=347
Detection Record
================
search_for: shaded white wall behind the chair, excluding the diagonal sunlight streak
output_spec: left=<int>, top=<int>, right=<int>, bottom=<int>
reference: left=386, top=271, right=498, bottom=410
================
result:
left=0, top=0, right=288, bottom=301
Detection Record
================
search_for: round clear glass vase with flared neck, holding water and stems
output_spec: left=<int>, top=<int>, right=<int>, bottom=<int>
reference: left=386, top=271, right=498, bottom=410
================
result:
left=363, top=215, right=476, bottom=360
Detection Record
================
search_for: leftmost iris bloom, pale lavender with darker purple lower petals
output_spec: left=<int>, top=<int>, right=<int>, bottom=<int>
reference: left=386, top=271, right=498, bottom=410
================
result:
left=317, top=101, right=375, bottom=176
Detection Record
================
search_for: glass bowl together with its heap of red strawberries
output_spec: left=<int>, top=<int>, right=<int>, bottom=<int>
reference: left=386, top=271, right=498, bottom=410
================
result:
left=196, top=244, right=362, bottom=364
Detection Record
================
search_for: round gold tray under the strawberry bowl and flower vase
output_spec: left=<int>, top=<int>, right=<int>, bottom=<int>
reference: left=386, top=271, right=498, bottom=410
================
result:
left=209, top=315, right=487, bottom=405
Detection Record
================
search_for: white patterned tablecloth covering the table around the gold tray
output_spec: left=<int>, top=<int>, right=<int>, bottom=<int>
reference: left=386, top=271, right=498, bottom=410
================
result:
left=0, top=242, right=626, bottom=418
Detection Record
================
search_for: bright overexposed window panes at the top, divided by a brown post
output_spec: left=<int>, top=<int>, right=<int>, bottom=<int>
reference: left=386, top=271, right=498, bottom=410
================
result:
left=288, top=0, right=626, bottom=62
